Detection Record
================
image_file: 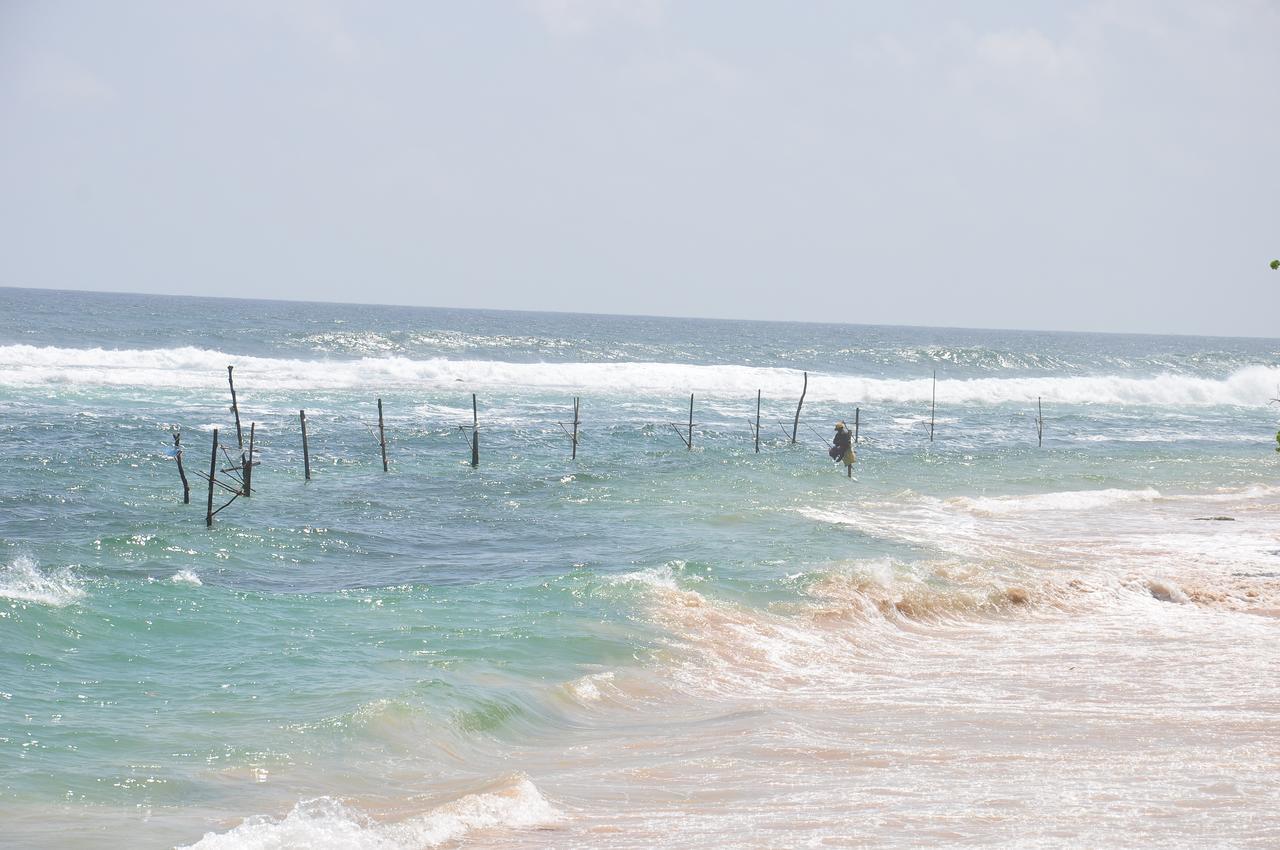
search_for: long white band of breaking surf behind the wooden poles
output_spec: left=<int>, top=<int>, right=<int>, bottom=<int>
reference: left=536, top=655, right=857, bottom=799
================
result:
left=0, top=346, right=1280, bottom=406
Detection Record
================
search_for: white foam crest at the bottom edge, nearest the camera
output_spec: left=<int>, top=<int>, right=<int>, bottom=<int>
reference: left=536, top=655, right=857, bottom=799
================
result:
left=183, top=777, right=562, bottom=850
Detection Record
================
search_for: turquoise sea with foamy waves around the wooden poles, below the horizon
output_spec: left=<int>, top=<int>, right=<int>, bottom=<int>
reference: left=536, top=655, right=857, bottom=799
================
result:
left=0, top=289, right=1280, bottom=849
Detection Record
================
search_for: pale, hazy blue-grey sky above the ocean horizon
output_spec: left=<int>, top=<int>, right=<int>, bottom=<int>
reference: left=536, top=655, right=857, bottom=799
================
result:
left=0, top=0, right=1280, bottom=337
